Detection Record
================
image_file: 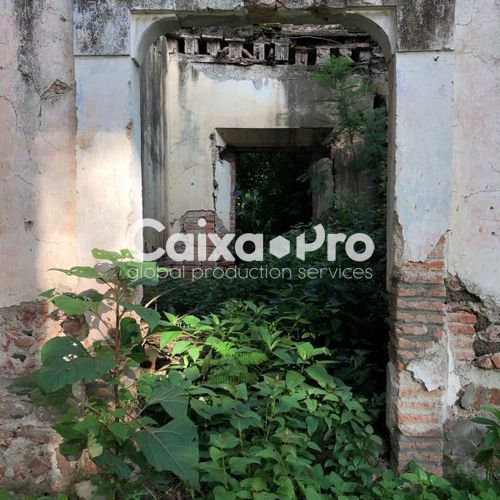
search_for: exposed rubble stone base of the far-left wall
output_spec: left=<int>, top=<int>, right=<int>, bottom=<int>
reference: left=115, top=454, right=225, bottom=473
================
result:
left=0, top=301, right=76, bottom=494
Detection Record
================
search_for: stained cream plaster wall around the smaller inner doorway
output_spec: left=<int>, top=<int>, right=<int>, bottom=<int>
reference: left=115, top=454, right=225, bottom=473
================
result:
left=163, top=58, right=331, bottom=232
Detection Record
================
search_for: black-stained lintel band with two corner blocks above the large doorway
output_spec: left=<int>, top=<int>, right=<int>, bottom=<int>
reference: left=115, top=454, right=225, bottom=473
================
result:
left=74, top=0, right=455, bottom=55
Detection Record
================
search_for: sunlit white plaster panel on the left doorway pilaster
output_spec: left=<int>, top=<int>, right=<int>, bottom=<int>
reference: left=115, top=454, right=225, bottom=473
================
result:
left=75, top=56, right=142, bottom=263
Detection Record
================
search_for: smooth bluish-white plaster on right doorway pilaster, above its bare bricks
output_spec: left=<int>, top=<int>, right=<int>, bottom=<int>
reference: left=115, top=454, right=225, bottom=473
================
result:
left=394, top=52, right=454, bottom=263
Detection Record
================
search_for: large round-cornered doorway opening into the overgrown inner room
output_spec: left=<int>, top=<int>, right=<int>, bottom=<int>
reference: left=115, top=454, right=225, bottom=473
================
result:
left=142, top=18, right=389, bottom=484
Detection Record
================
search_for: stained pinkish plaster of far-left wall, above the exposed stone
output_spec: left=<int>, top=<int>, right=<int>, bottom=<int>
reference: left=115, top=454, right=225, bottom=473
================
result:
left=0, top=0, right=76, bottom=307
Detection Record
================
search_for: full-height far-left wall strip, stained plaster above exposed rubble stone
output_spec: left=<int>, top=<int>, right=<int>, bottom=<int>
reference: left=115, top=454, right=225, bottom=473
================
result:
left=0, top=0, right=77, bottom=493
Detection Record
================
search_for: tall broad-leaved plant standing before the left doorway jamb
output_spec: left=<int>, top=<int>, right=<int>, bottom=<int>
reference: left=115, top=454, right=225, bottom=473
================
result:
left=13, top=249, right=198, bottom=498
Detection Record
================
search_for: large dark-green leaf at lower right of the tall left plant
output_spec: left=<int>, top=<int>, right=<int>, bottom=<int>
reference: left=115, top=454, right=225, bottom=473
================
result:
left=136, top=417, right=199, bottom=486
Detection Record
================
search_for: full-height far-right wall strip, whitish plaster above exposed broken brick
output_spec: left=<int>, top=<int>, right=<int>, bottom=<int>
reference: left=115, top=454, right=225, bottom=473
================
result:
left=445, top=0, right=500, bottom=472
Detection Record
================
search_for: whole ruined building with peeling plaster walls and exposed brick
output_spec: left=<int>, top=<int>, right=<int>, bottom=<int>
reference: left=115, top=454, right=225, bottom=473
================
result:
left=0, top=0, right=500, bottom=491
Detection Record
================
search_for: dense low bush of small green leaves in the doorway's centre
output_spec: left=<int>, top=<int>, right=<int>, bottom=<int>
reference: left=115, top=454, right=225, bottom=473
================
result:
left=148, top=301, right=381, bottom=499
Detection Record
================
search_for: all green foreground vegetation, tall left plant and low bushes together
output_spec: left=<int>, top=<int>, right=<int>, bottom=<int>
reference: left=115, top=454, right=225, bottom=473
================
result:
left=4, top=250, right=500, bottom=499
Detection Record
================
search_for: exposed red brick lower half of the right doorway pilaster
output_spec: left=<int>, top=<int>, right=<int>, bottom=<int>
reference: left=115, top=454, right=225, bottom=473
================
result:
left=387, top=240, right=447, bottom=473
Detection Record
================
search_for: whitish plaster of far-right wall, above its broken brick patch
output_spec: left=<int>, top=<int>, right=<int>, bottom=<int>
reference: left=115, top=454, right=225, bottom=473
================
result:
left=448, top=0, right=500, bottom=305
